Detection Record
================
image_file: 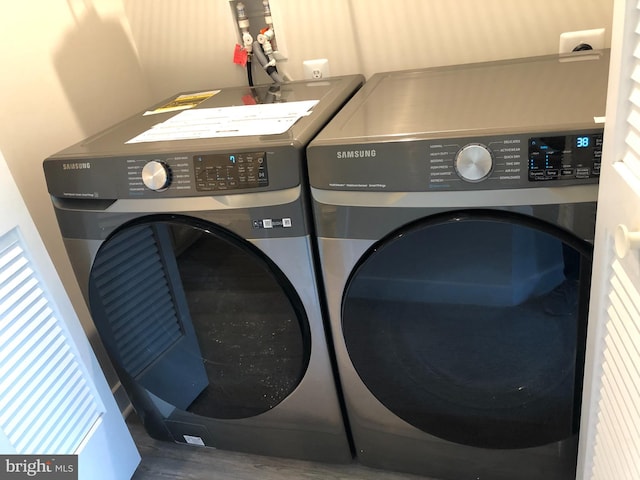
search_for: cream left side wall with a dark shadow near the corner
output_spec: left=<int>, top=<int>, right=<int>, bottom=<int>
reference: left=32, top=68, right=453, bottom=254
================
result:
left=0, top=0, right=150, bottom=394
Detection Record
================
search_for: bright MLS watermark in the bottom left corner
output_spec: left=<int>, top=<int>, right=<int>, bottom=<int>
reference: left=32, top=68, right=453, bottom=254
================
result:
left=0, top=455, right=78, bottom=480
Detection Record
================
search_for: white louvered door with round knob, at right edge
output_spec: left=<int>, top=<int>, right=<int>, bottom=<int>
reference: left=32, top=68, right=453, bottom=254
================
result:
left=577, top=0, right=640, bottom=480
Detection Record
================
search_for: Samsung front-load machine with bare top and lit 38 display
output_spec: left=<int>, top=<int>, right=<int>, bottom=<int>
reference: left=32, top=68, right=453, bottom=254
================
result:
left=307, top=51, right=608, bottom=480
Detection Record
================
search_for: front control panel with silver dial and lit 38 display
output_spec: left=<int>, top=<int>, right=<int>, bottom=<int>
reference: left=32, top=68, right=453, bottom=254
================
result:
left=308, top=128, right=603, bottom=192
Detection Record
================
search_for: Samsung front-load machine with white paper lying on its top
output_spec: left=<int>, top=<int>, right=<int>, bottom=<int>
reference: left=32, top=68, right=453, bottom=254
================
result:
left=44, top=75, right=363, bottom=463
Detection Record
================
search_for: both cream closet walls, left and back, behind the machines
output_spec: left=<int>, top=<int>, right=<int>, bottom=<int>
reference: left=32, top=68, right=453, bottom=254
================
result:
left=0, top=0, right=613, bottom=398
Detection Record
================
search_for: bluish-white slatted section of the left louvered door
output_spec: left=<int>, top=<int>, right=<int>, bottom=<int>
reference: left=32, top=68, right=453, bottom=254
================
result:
left=0, top=229, right=104, bottom=454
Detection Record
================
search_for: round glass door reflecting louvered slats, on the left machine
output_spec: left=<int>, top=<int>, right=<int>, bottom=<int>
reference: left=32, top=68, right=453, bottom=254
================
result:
left=89, top=216, right=311, bottom=419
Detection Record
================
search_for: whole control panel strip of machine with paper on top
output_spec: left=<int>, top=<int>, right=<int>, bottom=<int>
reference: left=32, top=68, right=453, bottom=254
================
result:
left=44, top=146, right=301, bottom=199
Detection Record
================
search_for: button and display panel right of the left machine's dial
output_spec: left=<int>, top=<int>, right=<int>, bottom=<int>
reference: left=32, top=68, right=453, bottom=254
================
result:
left=193, top=152, right=269, bottom=192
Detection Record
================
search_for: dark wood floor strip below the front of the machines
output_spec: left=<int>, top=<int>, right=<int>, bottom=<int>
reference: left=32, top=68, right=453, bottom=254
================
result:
left=127, top=414, right=436, bottom=480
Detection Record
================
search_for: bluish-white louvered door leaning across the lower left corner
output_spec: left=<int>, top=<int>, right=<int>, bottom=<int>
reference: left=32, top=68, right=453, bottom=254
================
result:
left=0, top=153, right=140, bottom=480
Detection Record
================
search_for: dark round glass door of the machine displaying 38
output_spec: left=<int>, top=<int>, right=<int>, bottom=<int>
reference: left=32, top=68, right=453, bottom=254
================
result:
left=342, top=210, right=591, bottom=448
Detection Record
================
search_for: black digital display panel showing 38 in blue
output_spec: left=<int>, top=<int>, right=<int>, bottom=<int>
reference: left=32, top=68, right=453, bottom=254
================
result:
left=529, top=133, right=602, bottom=181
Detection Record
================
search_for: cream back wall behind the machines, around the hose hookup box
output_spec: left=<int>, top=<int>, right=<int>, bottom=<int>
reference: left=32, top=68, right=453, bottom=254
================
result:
left=123, top=0, right=613, bottom=99
